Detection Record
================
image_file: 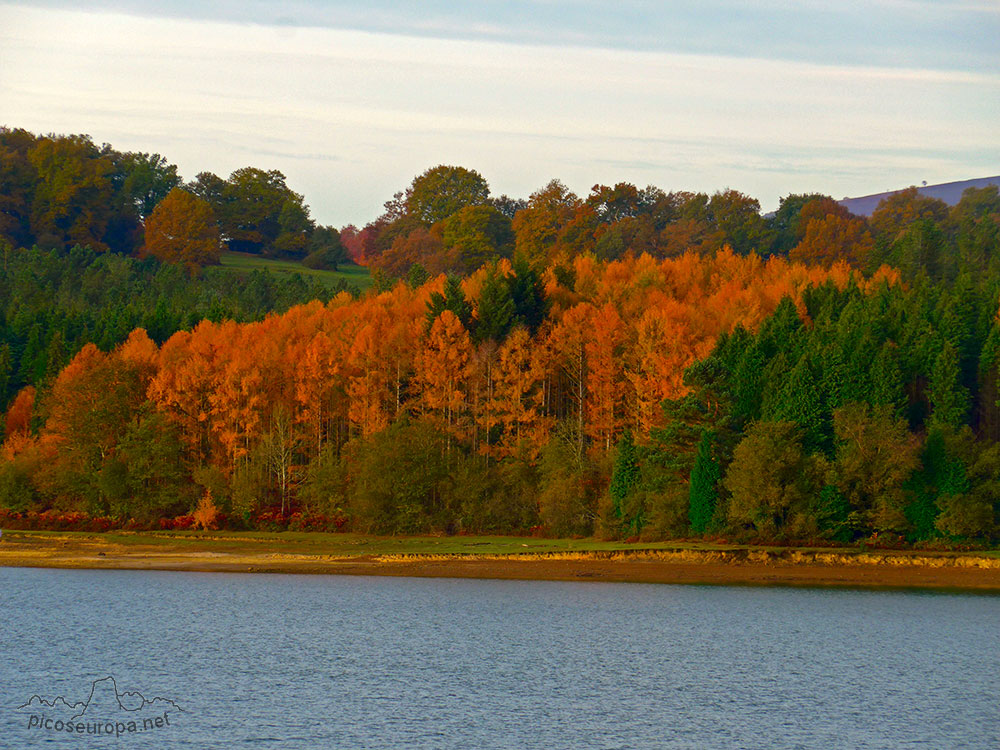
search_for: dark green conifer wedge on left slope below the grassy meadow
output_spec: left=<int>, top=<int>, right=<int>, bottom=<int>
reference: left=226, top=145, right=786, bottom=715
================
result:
left=0, top=247, right=356, bottom=406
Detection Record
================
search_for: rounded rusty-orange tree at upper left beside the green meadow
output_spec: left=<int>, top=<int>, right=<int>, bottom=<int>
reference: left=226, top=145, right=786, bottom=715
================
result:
left=143, top=188, right=221, bottom=274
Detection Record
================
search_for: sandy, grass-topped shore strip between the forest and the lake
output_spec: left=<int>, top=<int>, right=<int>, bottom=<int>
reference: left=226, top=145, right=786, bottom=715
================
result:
left=0, top=535, right=1000, bottom=593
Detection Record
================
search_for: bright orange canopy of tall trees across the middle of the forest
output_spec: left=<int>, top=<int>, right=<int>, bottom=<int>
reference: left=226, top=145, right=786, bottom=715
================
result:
left=27, top=253, right=898, bottom=471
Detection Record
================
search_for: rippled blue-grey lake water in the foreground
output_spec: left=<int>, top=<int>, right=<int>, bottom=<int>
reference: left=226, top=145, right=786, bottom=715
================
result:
left=0, top=568, right=1000, bottom=750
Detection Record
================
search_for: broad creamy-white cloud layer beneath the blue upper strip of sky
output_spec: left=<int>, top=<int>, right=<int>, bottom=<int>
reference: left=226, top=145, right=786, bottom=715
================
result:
left=0, top=6, right=1000, bottom=223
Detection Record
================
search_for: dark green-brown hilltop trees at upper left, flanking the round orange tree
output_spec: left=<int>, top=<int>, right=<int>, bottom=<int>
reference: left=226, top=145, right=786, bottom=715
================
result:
left=0, top=127, right=346, bottom=268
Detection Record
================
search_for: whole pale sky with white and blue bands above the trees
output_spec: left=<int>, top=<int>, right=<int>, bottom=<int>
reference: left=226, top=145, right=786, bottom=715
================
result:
left=0, top=0, right=1000, bottom=227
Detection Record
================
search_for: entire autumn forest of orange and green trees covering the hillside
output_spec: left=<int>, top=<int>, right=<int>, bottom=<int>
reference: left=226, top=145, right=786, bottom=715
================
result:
left=0, top=128, right=1000, bottom=545
